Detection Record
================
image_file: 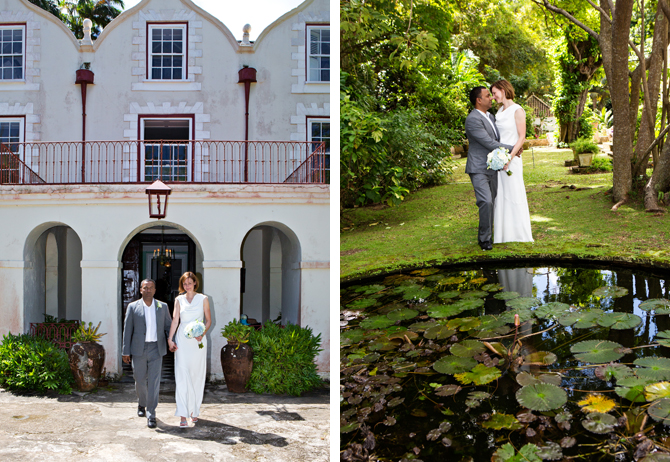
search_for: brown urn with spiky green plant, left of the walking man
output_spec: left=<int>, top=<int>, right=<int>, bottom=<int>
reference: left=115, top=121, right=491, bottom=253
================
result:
left=68, top=322, right=106, bottom=391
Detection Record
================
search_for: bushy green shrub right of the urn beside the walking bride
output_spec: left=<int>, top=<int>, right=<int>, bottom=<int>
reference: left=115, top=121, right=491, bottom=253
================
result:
left=247, top=321, right=322, bottom=396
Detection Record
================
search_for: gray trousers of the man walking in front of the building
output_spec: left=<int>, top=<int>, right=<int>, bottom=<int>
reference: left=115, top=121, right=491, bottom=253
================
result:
left=132, top=342, right=163, bottom=419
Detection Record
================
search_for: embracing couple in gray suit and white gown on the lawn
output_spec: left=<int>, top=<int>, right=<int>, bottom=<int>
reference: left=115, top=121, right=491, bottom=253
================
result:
left=465, top=80, right=533, bottom=250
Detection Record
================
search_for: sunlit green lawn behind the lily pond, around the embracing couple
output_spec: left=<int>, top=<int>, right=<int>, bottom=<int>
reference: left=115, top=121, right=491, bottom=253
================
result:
left=340, top=148, right=670, bottom=280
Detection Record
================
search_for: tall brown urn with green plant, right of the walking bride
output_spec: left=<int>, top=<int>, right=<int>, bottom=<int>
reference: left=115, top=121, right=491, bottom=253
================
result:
left=221, top=318, right=254, bottom=393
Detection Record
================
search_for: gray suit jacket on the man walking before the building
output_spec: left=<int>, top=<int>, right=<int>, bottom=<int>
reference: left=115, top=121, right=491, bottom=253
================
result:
left=121, top=299, right=172, bottom=356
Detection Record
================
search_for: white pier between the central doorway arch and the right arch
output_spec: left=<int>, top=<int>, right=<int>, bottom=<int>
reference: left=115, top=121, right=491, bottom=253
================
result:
left=202, top=260, right=242, bottom=380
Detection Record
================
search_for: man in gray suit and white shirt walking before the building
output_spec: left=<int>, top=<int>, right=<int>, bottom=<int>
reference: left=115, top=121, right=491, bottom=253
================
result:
left=122, top=279, right=172, bottom=428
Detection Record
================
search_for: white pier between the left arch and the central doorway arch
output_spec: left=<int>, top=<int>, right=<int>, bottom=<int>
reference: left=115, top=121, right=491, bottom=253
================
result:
left=81, top=260, right=123, bottom=374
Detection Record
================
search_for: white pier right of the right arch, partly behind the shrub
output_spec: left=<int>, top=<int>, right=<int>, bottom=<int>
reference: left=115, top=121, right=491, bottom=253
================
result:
left=300, top=261, right=330, bottom=374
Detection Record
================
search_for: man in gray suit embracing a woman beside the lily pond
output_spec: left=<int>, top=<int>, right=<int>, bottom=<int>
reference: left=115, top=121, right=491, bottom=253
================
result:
left=465, top=87, right=514, bottom=250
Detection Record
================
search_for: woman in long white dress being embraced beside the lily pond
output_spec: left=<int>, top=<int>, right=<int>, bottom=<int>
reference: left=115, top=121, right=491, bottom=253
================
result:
left=491, top=80, right=533, bottom=244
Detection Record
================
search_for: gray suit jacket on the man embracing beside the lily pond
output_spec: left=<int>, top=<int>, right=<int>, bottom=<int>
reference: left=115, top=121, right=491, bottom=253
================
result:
left=465, top=109, right=514, bottom=175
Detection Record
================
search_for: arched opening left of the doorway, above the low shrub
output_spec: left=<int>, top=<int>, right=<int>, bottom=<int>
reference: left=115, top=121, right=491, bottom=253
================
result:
left=23, top=223, right=82, bottom=332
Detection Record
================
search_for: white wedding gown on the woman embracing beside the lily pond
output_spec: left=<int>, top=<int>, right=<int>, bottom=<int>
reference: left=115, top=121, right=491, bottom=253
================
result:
left=493, top=104, right=533, bottom=244
